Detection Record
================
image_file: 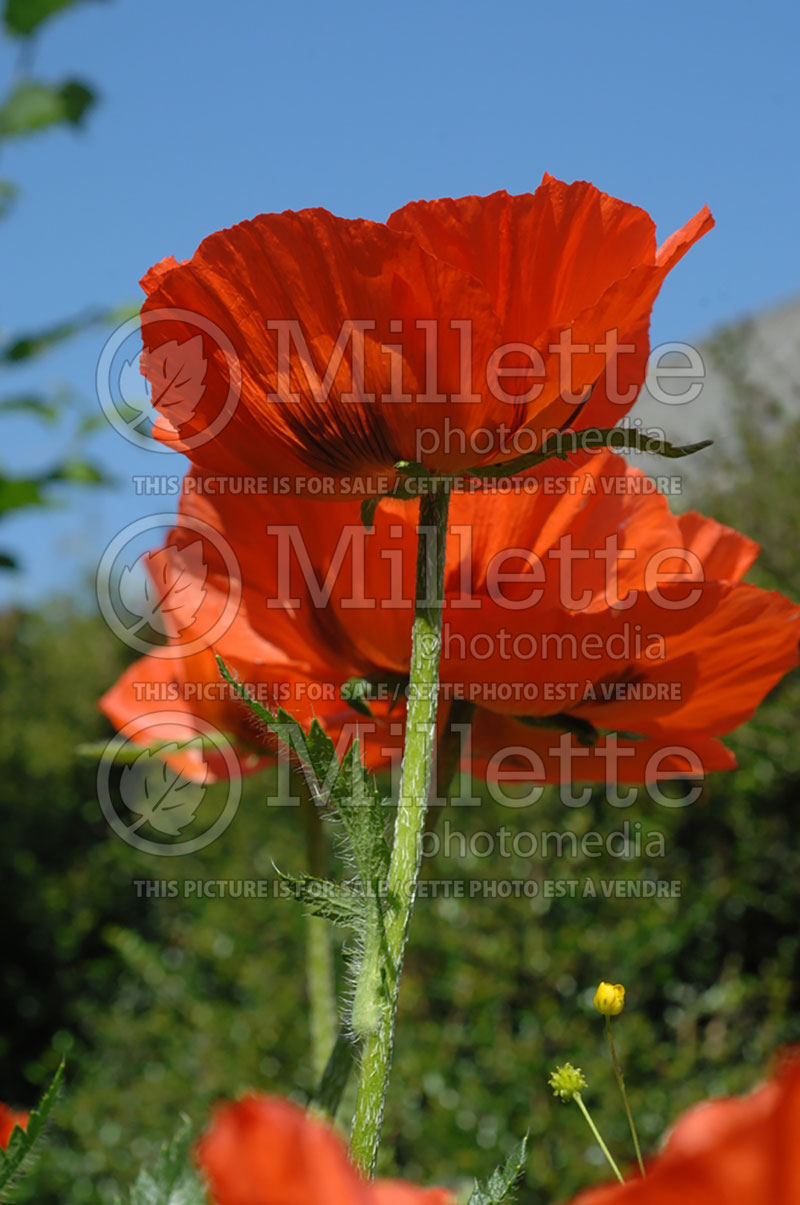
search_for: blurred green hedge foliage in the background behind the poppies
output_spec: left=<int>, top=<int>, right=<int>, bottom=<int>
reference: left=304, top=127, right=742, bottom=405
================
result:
left=0, top=371, right=800, bottom=1205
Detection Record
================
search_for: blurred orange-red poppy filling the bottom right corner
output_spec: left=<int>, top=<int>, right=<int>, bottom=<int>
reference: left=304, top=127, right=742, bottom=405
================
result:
left=573, top=1053, right=800, bottom=1205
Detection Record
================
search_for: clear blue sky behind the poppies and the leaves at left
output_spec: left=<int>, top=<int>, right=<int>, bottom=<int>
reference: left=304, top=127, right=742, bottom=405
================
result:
left=0, top=0, right=800, bottom=600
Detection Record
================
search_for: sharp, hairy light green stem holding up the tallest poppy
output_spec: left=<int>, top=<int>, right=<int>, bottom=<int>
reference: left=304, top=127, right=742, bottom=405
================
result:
left=351, top=482, right=449, bottom=1176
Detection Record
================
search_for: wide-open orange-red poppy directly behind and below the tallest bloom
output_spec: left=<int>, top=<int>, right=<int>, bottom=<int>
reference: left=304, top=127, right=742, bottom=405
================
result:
left=101, top=453, right=800, bottom=783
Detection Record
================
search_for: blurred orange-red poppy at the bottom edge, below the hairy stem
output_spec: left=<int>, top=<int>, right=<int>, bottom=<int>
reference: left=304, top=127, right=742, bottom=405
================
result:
left=198, top=1095, right=453, bottom=1205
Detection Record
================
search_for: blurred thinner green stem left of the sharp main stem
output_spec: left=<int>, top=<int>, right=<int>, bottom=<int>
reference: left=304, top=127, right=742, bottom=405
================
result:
left=298, top=782, right=339, bottom=1082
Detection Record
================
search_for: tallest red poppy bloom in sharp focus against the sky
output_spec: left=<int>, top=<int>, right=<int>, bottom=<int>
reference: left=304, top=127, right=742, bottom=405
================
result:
left=142, top=176, right=713, bottom=489
